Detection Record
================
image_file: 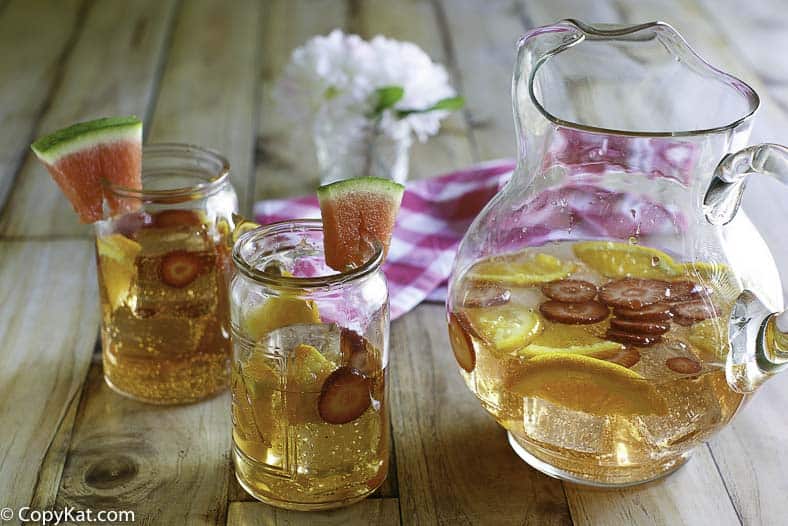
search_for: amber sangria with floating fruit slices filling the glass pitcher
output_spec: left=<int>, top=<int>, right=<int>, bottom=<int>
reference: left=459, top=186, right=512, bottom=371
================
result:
left=448, top=241, right=743, bottom=485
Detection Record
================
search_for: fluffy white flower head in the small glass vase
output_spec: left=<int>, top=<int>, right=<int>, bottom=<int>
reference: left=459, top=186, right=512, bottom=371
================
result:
left=276, top=30, right=456, bottom=142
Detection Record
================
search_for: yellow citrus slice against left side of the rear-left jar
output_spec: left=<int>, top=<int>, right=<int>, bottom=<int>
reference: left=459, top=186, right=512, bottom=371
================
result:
left=96, top=234, right=142, bottom=310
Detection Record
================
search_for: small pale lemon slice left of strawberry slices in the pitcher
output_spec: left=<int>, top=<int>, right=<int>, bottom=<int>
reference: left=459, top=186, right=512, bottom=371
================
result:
left=465, top=305, right=544, bottom=352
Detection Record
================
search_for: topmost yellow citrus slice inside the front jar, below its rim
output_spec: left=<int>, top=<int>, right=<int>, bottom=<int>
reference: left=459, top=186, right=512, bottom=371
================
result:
left=244, top=296, right=320, bottom=340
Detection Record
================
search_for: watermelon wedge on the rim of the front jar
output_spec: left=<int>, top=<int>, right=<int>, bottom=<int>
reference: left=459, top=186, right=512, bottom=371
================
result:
left=317, top=177, right=405, bottom=272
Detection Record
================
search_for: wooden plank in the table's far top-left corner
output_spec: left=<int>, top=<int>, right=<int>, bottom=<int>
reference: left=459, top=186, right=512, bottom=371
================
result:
left=0, top=0, right=84, bottom=214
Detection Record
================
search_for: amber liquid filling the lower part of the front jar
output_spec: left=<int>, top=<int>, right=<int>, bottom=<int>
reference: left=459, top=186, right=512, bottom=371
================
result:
left=230, top=326, right=389, bottom=510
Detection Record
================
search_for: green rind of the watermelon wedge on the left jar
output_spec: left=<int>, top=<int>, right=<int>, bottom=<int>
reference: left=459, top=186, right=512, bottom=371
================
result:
left=30, top=115, right=142, bottom=164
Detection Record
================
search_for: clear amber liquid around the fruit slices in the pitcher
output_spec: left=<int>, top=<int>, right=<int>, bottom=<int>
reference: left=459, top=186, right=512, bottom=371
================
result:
left=452, top=243, right=743, bottom=485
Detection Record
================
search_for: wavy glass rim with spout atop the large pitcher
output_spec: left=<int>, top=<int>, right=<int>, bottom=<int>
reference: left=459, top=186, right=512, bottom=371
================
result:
left=520, top=18, right=761, bottom=137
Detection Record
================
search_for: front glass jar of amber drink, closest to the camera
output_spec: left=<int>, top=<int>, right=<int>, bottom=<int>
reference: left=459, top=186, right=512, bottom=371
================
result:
left=230, top=220, right=389, bottom=510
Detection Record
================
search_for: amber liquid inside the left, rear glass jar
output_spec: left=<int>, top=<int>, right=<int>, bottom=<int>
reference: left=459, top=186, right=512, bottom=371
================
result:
left=97, top=221, right=232, bottom=404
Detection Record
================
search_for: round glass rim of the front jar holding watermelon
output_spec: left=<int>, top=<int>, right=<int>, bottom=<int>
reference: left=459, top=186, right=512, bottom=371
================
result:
left=233, top=219, right=383, bottom=289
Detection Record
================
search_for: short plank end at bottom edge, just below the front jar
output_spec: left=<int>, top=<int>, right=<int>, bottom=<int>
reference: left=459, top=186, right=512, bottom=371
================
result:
left=227, top=499, right=400, bottom=526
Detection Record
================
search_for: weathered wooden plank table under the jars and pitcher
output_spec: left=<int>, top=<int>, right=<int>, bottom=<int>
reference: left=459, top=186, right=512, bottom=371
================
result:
left=0, top=0, right=788, bottom=525
